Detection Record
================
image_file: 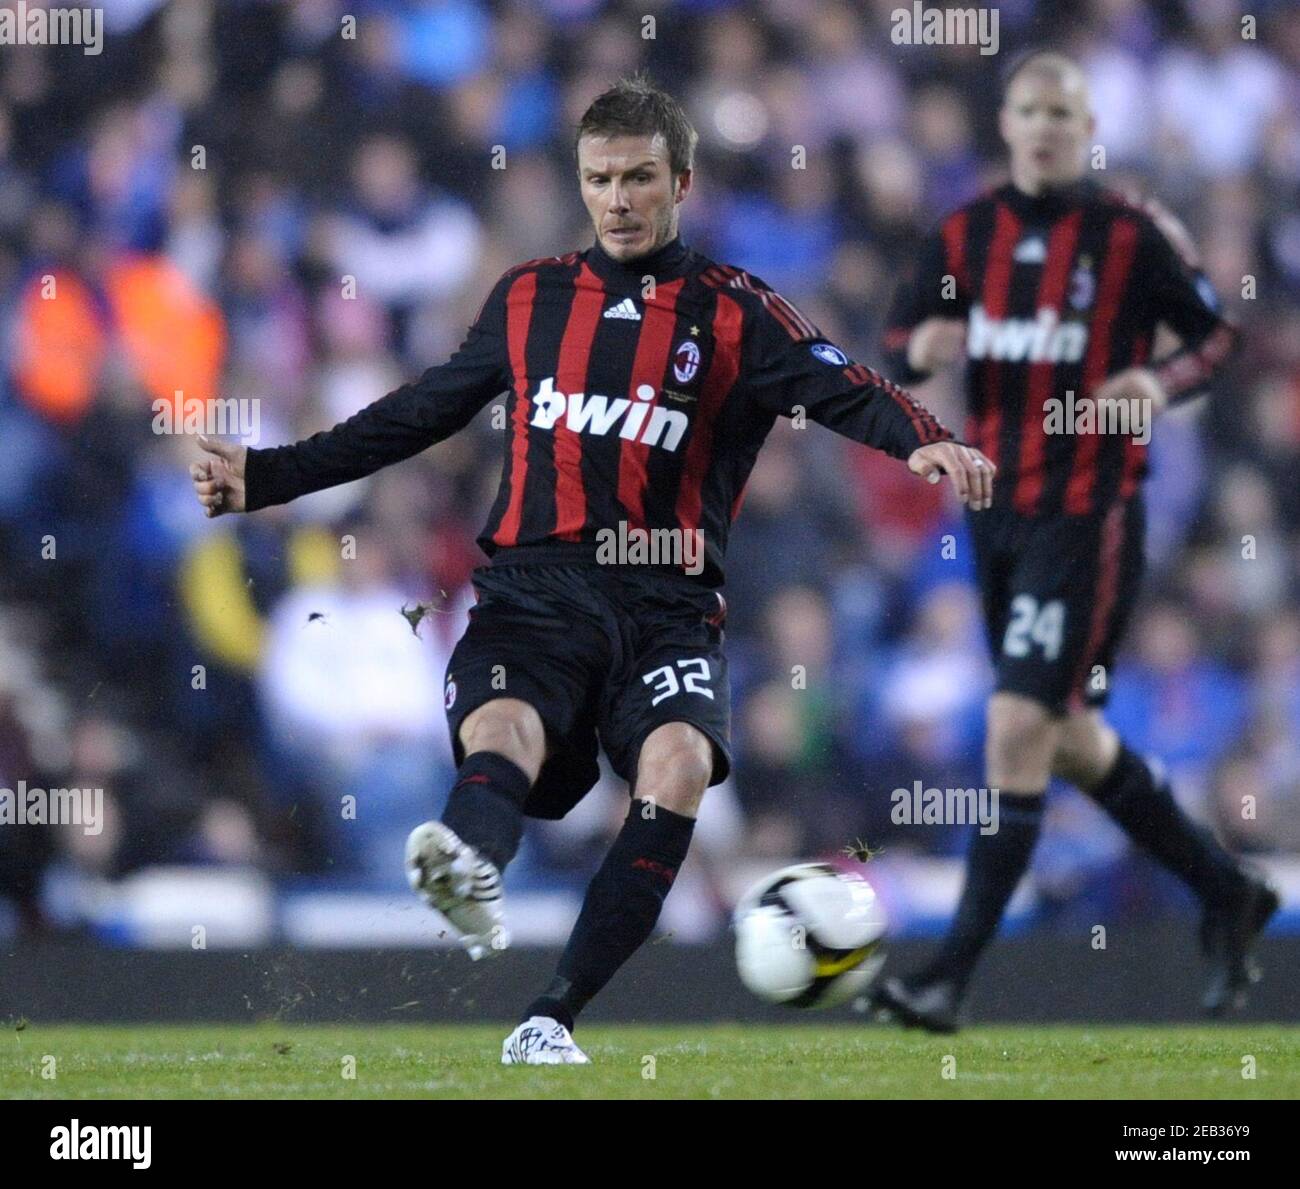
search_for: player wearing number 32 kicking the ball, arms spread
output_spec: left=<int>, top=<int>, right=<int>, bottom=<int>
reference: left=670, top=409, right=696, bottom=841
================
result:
left=191, top=79, right=993, bottom=1064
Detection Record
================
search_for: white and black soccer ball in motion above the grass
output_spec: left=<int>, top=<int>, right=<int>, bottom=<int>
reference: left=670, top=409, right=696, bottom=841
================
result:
left=733, top=863, right=885, bottom=1007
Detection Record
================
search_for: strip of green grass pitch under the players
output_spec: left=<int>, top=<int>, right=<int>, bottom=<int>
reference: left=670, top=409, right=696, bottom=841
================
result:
left=0, top=1023, right=1300, bottom=1099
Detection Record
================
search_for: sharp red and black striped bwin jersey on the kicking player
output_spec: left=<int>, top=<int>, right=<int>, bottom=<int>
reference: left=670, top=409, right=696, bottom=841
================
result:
left=246, top=239, right=952, bottom=585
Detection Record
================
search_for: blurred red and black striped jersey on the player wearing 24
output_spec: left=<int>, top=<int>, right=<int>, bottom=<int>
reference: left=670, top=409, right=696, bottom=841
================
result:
left=884, top=179, right=1238, bottom=516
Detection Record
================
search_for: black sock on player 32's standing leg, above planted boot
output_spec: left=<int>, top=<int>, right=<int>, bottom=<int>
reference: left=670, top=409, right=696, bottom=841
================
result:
left=524, top=800, right=696, bottom=1028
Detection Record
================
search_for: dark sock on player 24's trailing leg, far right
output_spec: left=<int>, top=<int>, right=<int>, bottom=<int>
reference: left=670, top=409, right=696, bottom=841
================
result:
left=1084, top=743, right=1244, bottom=903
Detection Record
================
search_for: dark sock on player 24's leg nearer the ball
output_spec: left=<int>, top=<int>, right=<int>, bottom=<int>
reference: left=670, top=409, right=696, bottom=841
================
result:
left=913, top=790, right=1047, bottom=995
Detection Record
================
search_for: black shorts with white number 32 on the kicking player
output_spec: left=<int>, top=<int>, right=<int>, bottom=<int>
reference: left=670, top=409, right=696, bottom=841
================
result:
left=445, top=564, right=731, bottom=819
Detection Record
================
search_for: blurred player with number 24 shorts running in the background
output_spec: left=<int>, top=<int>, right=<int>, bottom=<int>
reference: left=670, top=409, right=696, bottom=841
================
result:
left=876, top=52, right=1278, bottom=1032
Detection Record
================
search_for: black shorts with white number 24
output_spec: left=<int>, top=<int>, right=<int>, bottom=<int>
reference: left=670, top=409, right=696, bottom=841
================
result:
left=967, top=495, right=1145, bottom=715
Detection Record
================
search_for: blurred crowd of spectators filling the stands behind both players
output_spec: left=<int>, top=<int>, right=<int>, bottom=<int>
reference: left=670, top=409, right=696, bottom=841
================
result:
left=0, top=0, right=1300, bottom=946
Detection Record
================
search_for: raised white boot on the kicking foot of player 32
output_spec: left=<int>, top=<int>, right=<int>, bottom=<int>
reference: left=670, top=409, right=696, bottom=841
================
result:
left=406, top=821, right=510, bottom=962
